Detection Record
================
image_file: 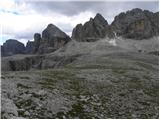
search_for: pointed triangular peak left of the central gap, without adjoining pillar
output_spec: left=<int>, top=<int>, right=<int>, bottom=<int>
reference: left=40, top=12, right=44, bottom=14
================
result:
left=38, top=24, right=71, bottom=53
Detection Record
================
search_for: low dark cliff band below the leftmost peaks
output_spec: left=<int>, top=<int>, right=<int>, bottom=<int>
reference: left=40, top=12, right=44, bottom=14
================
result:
left=1, top=55, right=44, bottom=71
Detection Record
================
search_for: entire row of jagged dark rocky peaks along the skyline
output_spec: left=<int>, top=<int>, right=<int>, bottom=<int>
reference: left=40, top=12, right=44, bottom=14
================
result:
left=1, top=8, right=159, bottom=56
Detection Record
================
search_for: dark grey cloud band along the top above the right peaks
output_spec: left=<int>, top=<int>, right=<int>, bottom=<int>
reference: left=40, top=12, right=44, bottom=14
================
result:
left=28, top=1, right=159, bottom=17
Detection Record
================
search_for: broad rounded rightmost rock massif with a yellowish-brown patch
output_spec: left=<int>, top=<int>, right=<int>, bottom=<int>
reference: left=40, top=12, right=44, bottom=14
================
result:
left=111, top=8, right=159, bottom=39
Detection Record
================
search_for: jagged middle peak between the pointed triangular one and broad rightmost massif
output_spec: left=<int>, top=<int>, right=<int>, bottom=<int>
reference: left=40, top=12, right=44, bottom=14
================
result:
left=72, top=13, right=113, bottom=42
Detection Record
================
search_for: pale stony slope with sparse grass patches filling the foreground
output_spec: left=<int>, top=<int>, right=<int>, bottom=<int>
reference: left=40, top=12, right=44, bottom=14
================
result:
left=1, top=40, right=159, bottom=118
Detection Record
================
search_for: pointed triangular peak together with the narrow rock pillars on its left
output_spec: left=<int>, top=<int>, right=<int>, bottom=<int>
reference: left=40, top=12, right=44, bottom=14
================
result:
left=27, top=24, right=71, bottom=54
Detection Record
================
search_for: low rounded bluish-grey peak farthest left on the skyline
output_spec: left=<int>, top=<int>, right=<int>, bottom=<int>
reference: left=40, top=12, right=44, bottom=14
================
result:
left=1, top=39, right=25, bottom=56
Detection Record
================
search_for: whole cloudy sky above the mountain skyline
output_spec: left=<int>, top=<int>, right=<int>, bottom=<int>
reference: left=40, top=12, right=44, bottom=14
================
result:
left=0, top=0, right=159, bottom=45
